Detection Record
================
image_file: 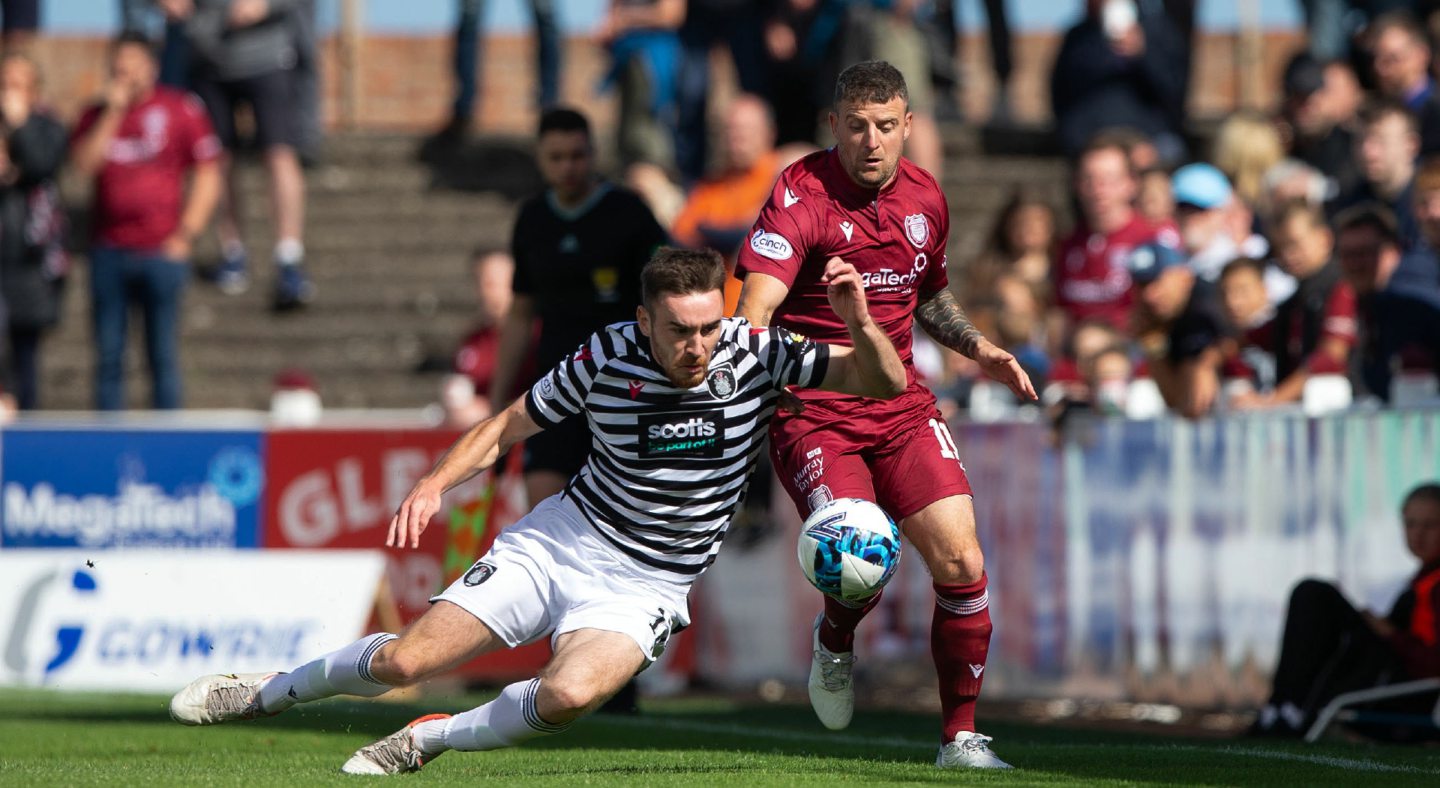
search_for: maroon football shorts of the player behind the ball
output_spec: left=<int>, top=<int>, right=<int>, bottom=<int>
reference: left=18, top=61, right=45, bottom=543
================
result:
left=770, top=383, right=971, bottom=521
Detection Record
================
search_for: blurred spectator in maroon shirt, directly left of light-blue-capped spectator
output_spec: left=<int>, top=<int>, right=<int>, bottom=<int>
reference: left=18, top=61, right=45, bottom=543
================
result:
left=1051, top=135, right=1179, bottom=333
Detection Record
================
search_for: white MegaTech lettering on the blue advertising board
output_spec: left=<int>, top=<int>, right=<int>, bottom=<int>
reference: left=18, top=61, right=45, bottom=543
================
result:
left=4, top=481, right=236, bottom=547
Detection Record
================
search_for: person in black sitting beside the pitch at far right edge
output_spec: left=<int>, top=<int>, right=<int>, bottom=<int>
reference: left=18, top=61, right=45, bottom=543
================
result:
left=1250, top=483, right=1440, bottom=738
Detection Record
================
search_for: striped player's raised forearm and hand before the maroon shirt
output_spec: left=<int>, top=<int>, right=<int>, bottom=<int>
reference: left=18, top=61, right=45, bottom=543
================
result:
left=819, top=258, right=906, bottom=399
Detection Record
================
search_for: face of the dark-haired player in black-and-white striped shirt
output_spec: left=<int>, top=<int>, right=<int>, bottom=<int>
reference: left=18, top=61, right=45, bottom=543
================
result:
left=635, top=290, right=724, bottom=389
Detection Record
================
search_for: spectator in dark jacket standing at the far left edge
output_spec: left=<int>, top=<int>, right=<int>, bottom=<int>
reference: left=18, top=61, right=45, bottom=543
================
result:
left=0, top=55, right=69, bottom=411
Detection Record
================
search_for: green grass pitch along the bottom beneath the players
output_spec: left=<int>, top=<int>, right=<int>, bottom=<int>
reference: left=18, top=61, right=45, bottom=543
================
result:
left=0, top=690, right=1440, bottom=788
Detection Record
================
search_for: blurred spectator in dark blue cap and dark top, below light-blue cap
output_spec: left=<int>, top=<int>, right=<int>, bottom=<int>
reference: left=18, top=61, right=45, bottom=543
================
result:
left=1128, top=237, right=1227, bottom=418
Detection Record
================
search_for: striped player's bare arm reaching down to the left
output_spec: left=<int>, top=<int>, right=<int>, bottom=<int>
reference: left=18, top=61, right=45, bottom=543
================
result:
left=384, top=398, right=540, bottom=547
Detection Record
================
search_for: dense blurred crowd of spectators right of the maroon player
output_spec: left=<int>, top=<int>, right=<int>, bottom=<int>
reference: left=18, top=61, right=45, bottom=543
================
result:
left=917, top=0, right=1440, bottom=418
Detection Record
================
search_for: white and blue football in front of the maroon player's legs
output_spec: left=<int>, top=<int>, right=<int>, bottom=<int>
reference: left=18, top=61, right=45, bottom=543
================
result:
left=798, top=498, right=900, bottom=602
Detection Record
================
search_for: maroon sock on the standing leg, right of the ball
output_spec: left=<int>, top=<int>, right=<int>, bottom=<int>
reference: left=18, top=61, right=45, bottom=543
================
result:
left=930, top=575, right=991, bottom=743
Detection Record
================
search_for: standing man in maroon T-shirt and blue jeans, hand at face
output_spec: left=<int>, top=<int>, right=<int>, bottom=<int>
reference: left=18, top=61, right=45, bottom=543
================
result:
left=71, top=33, right=220, bottom=411
